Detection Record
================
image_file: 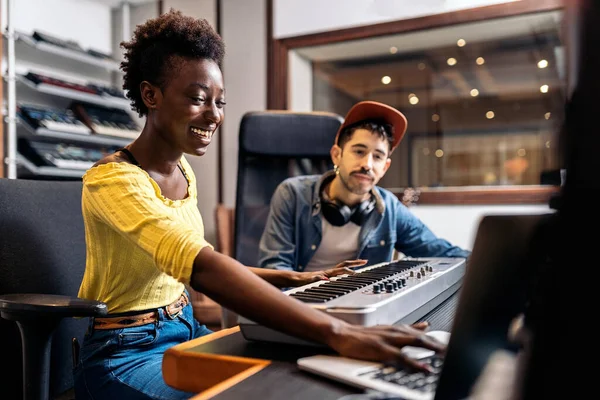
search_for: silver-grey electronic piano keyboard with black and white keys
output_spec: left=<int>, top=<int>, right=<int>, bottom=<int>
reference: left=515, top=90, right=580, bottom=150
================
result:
left=239, top=258, right=466, bottom=344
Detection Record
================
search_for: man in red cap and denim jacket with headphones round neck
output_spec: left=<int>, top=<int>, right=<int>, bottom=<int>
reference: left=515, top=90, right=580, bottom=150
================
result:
left=258, top=101, right=470, bottom=271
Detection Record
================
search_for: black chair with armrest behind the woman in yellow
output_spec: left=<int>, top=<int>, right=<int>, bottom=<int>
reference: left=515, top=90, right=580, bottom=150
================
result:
left=0, top=179, right=107, bottom=399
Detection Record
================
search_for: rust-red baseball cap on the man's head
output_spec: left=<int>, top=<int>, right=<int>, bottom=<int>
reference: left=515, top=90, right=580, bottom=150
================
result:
left=335, top=101, right=408, bottom=154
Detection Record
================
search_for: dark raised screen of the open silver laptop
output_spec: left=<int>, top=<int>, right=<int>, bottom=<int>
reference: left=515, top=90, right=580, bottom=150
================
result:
left=435, top=213, right=553, bottom=400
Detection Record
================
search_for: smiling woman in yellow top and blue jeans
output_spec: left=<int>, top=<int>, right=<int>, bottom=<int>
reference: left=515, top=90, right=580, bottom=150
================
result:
left=75, top=11, right=443, bottom=400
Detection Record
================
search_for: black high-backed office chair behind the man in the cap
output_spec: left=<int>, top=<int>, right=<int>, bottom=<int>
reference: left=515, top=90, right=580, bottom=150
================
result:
left=223, top=111, right=343, bottom=327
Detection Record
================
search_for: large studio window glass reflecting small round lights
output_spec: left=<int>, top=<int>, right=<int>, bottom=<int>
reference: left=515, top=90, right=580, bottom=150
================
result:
left=298, top=11, right=566, bottom=188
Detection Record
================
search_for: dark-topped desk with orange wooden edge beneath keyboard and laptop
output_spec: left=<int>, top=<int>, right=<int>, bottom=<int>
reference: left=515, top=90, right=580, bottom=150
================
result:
left=163, top=293, right=458, bottom=400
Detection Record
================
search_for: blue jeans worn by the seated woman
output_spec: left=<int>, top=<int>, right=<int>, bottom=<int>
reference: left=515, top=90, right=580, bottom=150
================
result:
left=73, top=303, right=212, bottom=400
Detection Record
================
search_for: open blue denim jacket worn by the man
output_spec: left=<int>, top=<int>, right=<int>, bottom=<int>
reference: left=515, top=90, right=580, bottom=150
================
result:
left=258, top=171, right=470, bottom=271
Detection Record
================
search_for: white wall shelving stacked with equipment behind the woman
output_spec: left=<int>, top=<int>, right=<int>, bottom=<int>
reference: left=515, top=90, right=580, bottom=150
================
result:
left=0, top=0, right=131, bottom=179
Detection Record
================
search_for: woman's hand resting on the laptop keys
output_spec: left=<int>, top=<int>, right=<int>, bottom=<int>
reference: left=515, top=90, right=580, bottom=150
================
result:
left=328, top=322, right=446, bottom=372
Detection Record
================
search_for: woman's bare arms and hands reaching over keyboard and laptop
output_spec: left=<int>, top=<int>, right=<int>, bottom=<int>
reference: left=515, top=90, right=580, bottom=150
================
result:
left=191, top=247, right=445, bottom=370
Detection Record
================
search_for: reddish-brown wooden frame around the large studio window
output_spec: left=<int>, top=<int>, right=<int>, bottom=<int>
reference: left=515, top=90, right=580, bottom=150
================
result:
left=267, top=0, right=569, bottom=205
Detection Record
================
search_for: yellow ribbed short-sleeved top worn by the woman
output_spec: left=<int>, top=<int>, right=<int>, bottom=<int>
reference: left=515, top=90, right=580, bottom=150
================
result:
left=79, top=157, right=212, bottom=313
